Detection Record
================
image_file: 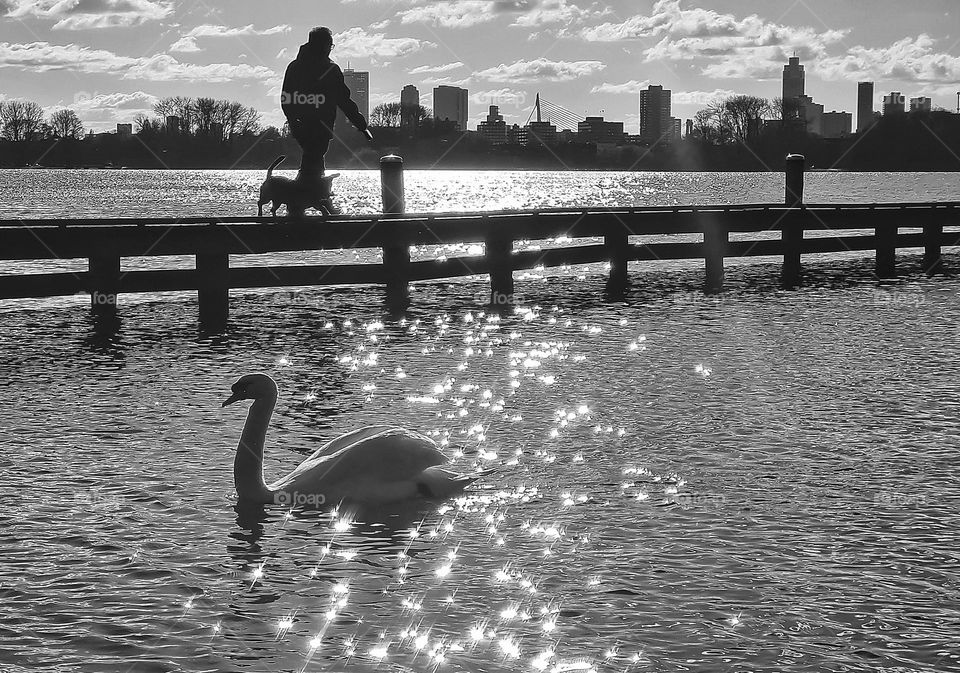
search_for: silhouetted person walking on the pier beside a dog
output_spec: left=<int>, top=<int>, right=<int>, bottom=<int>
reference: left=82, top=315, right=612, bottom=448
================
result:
left=280, top=27, right=373, bottom=213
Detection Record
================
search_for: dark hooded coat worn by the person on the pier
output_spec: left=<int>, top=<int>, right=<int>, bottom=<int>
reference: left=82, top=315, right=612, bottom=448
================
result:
left=280, top=43, right=367, bottom=140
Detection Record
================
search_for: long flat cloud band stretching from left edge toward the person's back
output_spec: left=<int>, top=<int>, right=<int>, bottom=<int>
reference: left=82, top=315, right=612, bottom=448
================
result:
left=0, top=42, right=277, bottom=82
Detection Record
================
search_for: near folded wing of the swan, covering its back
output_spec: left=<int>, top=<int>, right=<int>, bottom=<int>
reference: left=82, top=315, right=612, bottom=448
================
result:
left=277, top=426, right=447, bottom=487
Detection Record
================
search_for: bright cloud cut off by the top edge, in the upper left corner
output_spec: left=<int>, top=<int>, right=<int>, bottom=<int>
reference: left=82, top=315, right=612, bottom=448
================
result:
left=7, top=0, right=173, bottom=30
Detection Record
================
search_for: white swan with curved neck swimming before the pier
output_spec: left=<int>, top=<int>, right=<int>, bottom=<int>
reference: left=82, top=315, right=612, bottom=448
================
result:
left=221, top=374, right=481, bottom=506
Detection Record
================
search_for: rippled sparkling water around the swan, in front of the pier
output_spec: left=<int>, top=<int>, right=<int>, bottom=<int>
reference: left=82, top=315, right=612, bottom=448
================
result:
left=0, top=171, right=960, bottom=673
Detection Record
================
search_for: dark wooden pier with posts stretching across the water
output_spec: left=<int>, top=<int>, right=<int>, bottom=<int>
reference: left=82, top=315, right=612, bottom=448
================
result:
left=0, top=155, right=960, bottom=327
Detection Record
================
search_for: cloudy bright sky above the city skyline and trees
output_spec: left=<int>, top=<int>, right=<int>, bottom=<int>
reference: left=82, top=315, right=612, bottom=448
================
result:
left=0, top=0, right=960, bottom=133
